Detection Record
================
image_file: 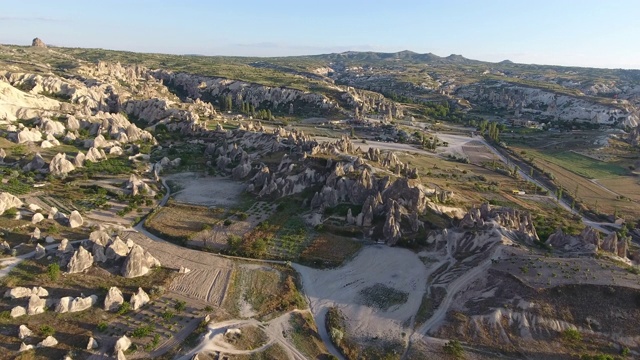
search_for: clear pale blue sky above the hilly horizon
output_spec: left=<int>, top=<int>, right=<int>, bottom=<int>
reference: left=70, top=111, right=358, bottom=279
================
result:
left=0, top=0, right=640, bottom=69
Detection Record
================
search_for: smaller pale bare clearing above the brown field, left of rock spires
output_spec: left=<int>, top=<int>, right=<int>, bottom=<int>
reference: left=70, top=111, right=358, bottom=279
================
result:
left=165, top=173, right=245, bottom=207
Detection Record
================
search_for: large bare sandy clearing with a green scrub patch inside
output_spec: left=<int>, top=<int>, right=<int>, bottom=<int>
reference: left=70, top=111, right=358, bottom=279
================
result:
left=293, top=245, right=426, bottom=343
